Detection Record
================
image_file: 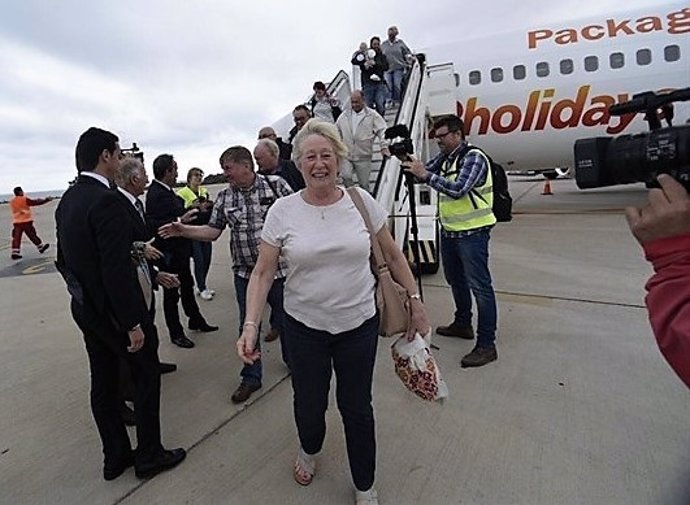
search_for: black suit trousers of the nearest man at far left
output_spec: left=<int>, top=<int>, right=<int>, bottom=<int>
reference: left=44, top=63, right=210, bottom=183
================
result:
left=72, top=301, right=163, bottom=465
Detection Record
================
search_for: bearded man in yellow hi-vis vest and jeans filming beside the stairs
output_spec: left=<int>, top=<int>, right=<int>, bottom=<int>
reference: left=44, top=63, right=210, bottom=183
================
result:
left=403, top=115, right=498, bottom=367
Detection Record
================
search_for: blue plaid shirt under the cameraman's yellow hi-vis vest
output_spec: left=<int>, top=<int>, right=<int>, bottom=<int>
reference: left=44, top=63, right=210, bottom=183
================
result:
left=426, top=140, right=491, bottom=238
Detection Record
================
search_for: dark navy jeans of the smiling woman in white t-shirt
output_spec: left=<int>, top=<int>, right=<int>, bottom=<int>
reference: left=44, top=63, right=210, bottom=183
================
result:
left=285, top=314, right=379, bottom=491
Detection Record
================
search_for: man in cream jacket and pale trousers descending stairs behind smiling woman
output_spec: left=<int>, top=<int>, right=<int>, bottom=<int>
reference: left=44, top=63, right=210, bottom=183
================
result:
left=335, top=90, right=390, bottom=192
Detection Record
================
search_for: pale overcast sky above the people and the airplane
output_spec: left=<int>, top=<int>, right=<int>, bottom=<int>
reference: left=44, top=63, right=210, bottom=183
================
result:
left=0, top=0, right=668, bottom=194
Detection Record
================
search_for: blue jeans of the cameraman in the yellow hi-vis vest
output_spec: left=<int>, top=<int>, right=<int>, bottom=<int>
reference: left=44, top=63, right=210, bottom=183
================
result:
left=441, top=230, right=497, bottom=347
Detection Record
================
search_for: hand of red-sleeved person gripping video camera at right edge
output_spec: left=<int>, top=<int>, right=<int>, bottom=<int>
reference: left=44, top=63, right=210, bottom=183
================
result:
left=625, top=174, right=690, bottom=244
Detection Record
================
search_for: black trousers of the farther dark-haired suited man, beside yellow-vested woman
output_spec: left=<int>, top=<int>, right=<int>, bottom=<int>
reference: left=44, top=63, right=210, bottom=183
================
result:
left=163, top=247, right=204, bottom=339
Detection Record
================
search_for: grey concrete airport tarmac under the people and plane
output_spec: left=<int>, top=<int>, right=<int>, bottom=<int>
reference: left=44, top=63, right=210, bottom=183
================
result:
left=0, top=177, right=690, bottom=505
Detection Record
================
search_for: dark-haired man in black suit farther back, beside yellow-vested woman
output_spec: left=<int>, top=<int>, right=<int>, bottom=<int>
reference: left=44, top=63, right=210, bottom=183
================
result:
left=146, top=154, right=218, bottom=348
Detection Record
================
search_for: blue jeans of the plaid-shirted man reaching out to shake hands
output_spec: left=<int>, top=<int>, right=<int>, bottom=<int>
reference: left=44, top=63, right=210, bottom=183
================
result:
left=234, top=275, right=290, bottom=385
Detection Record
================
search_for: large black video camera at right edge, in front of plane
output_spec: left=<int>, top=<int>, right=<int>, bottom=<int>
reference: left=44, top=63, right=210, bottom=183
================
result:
left=575, top=88, right=690, bottom=192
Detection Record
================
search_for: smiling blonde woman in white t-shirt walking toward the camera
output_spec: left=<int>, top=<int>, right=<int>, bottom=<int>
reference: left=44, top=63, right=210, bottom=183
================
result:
left=237, top=119, right=429, bottom=505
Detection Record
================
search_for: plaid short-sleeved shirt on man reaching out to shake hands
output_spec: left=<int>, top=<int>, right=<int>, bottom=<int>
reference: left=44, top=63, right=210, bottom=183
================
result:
left=208, top=175, right=292, bottom=279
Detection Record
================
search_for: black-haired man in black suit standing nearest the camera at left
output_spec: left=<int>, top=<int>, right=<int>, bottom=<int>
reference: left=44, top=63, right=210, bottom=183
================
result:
left=55, top=128, right=186, bottom=480
